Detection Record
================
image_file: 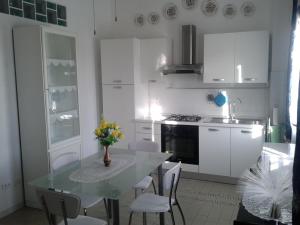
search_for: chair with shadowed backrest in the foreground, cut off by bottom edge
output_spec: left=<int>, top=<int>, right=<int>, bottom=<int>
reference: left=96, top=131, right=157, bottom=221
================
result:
left=36, top=188, right=107, bottom=225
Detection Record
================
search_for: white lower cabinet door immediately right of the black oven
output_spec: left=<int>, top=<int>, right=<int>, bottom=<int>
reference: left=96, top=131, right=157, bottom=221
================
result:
left=199, top=127, right=230, bottom=176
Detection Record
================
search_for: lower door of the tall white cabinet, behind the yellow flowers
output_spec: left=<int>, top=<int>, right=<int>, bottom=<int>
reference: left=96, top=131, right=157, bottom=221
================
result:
left=102, top=85, right=135, bottom=148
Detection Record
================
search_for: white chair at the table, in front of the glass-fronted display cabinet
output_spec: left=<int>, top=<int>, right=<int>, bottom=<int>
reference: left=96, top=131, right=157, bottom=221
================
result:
left=51, top=152, right=110, bottom=221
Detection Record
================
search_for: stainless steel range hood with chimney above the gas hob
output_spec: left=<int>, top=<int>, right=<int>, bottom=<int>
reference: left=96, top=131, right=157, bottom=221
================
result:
left=161, top=25, right=202, bottom=75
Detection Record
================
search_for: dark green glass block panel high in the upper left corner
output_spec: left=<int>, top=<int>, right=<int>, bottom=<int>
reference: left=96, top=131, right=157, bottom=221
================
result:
left=0, top=0, right=67, bottom=26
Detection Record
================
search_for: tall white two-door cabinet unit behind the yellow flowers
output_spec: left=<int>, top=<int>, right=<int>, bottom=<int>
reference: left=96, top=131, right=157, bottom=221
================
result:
left=101, top=38, right=147, bottom=148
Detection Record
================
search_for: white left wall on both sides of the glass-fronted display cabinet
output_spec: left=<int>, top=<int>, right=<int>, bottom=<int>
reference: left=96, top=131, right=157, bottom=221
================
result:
left=0, top=0, right=108, bottom=216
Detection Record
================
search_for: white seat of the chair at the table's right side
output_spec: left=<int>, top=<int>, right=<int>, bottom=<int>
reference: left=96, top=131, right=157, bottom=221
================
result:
left=130, top=193, right=175, bottom=213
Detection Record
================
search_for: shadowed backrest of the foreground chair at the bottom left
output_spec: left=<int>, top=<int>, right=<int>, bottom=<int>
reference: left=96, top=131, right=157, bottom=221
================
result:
left=36, top=188, right=81, bottom=219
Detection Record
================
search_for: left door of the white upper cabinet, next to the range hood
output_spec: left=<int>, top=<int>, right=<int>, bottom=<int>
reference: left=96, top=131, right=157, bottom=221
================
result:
left=203, top=33, right=235, bottom=83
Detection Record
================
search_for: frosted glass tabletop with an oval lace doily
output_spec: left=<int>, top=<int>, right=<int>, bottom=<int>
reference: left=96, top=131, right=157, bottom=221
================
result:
left=30, top=148, right=171, bottom=200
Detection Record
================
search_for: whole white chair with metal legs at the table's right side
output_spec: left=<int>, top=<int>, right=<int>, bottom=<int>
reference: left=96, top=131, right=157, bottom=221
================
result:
left=129, top=163, right=185, bottom=225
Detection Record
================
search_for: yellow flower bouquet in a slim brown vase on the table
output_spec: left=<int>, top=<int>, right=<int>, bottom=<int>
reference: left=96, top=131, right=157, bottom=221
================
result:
left=95, top=119, right=124, bottom=166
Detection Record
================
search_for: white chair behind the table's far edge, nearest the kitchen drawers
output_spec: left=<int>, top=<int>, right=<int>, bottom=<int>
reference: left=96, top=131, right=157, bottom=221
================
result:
left=128, top=141, right=160, bottom=197
